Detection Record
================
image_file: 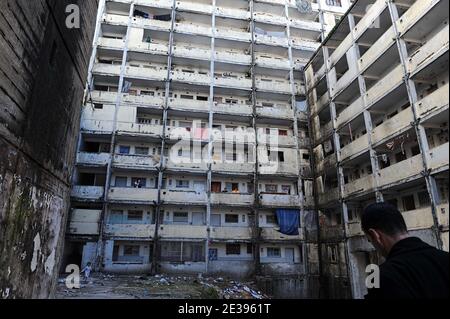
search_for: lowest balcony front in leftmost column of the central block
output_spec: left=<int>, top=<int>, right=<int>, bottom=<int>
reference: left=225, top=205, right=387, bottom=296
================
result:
left=67, top=209, right=102, bottom=236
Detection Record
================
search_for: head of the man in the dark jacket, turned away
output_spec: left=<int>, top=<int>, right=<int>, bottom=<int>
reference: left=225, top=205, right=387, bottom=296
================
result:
left=361, top=203, right=409, bottom=257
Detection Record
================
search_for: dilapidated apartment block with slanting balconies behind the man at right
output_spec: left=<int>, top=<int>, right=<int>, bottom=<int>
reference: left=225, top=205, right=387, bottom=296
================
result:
left=305, top=0, right=449, bottom=298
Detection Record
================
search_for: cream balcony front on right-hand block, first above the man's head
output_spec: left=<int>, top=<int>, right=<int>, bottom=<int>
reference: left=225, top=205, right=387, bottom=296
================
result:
left=379, top=154, right=423, bottom=187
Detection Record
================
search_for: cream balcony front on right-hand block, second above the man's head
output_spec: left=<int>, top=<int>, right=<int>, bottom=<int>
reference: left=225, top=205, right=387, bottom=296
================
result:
left=372, top=108, right=414, bottom=144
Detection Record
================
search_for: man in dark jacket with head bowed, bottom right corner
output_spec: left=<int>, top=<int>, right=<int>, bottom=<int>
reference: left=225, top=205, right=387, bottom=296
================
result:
left=362, top=203, right=450, bottom=299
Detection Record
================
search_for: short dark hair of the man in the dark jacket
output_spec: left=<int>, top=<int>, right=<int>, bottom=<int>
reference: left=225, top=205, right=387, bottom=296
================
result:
left=361, top=203, right=408, bottom=236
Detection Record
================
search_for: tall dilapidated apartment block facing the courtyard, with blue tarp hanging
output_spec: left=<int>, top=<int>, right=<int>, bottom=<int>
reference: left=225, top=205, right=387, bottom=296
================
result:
left=63, top=0, right=350, bottom=296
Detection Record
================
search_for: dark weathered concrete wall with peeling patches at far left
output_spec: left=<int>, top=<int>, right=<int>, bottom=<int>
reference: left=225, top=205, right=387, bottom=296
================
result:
left=0, top=0, right=98, bottom=298
